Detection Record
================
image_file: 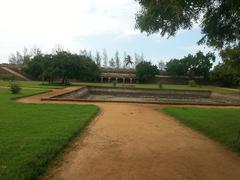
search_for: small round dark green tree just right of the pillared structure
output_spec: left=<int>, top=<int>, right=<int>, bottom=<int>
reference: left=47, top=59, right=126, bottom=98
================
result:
left=136, top=61, right=159, bottom=83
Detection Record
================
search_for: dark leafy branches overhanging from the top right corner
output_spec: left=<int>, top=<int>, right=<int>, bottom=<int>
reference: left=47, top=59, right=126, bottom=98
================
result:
left=136, top=0, right=240, bottom=48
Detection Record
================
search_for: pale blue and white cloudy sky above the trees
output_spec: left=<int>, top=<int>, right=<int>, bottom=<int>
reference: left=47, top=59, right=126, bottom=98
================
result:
left=0, top=0, right=217, bottom=64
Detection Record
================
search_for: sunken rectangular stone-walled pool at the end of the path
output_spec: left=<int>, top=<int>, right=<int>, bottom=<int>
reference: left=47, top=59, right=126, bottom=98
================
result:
left=42, top=86, right=240, bottom=106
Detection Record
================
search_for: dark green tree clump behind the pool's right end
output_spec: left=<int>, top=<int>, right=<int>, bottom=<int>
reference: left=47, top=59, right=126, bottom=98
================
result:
left=166, top=51, right=215, bottom=79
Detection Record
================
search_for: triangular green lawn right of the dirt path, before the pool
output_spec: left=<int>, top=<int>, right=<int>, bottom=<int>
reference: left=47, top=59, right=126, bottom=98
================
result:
left=162, top=107, right=240, bottom=152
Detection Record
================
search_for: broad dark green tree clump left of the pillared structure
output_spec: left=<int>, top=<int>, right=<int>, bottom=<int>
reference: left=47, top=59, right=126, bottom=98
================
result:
left=23, top=51, right=100, bottom=84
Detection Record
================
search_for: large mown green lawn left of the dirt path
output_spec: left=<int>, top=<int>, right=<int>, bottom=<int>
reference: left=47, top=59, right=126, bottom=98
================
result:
left=0, top=88, right=98, bottom=180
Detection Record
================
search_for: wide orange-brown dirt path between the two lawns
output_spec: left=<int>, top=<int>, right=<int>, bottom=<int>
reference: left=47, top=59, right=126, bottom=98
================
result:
left=17, top=90, right=240, bottom=180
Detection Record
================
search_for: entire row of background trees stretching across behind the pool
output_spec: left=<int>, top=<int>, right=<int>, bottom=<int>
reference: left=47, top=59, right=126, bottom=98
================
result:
left=9, top=48, right=240, bottom=86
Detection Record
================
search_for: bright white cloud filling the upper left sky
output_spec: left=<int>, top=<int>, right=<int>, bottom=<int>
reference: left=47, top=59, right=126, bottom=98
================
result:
left=0, top=0, right=139, bottom=62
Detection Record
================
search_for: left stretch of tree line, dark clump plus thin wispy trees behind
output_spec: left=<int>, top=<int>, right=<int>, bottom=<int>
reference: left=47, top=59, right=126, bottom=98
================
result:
left=9, top=46, right=150, bottom=84
